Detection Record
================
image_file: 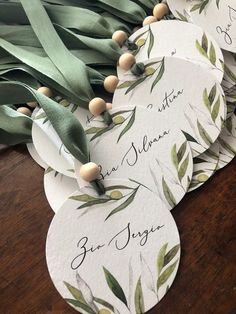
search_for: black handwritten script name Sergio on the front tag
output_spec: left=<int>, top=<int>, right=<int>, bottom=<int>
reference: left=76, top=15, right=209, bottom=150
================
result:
left=71, top=222, right=165, bottom=270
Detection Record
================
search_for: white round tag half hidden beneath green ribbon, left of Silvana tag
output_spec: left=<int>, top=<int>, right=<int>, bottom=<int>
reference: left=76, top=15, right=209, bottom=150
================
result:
left=32, top=104, right=93, bottom=178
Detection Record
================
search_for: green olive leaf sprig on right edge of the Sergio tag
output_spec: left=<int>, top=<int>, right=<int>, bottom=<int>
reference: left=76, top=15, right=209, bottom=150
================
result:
left=156, top=243, right=180, bottom=292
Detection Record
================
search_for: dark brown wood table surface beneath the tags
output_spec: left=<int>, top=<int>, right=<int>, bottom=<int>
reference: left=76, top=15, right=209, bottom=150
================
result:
left=0, top=146, right=236, bottom=314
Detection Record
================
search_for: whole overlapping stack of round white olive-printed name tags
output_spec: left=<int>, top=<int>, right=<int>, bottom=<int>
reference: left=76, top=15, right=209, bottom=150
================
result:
left=28, top=4, right=236, bottom=314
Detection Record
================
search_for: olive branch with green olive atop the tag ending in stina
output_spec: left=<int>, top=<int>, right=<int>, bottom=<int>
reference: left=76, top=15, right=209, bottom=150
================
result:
left=117, top=58, right=165, bottom=95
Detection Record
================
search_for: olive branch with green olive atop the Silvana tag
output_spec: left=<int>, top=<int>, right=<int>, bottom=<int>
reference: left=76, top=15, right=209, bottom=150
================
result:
left=85, top=108, right=136, bottom=143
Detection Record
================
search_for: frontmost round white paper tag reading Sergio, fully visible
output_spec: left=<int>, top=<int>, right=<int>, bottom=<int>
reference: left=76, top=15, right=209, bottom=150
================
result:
left=46, top=180, right=180, bottom=314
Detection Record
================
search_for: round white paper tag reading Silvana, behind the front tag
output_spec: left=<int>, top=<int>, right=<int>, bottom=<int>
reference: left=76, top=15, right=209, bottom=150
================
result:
left=86, top=106, right=193, bottom=209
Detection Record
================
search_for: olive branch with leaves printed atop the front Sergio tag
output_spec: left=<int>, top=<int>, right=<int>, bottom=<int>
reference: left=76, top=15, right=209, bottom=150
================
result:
left=69, top=179, right=144, bottom=220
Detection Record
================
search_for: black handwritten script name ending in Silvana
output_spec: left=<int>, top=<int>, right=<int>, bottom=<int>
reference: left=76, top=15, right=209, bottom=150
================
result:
left=100, top=130, right=170, bottom=180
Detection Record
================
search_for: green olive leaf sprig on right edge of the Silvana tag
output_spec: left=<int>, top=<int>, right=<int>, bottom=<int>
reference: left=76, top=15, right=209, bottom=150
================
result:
left=171, top=141, right=190, bottom=182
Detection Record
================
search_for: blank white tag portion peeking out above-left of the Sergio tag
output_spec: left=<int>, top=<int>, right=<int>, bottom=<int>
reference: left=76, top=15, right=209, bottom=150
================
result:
left=44, top=167, right=79, bottom=213
